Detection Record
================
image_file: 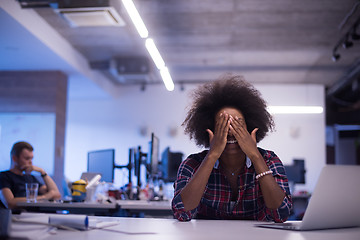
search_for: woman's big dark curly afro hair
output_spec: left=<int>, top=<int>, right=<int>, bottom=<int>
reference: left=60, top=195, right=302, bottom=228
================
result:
left=182, top=75, right=274, bottom=148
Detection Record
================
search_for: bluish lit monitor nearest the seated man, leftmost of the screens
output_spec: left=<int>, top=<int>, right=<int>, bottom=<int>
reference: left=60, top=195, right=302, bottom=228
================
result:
left=87, top=149, right=115, bottom=182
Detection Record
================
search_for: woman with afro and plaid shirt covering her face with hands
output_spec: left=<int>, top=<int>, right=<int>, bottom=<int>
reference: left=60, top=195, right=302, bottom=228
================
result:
left=172, top=75, right=292, bottom=222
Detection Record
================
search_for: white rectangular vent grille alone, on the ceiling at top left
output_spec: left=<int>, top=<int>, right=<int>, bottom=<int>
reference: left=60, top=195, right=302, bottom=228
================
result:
left=54, top=7, right=125, bottom=27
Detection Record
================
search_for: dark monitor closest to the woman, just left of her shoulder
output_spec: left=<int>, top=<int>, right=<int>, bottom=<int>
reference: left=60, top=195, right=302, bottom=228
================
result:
left=161, top=147, right=184, bottom=182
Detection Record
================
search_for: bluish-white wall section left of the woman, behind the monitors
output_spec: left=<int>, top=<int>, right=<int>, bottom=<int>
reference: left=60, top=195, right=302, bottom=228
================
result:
left=65, top=85, right=199, bottom=186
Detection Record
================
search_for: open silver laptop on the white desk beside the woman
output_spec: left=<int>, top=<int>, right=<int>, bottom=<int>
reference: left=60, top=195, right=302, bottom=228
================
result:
left=256, top=165, right=360, bottom=231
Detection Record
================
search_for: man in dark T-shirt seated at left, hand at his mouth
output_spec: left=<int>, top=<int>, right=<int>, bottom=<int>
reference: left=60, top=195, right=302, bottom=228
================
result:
left=0, top=142, right=61, bottom=209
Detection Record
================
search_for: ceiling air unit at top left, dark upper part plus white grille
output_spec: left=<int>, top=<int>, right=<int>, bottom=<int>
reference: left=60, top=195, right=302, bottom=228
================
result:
left=55, top=0, right=125, bottom=27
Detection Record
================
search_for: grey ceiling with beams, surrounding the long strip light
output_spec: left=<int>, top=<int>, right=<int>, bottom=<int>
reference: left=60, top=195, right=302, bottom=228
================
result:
left=0, top=0, right=360, bottom=97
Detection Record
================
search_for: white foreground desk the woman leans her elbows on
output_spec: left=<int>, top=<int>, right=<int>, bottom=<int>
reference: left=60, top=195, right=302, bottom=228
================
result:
left=9, top=216, right=360, bottom=240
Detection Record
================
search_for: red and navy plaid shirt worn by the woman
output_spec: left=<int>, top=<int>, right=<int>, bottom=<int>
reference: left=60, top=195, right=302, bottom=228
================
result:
left=172, top=148, right=292, bottom=222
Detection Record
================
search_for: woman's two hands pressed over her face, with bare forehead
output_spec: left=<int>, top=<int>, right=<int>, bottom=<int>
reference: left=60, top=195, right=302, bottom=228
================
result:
left=207, top=109, right=258, bottom=157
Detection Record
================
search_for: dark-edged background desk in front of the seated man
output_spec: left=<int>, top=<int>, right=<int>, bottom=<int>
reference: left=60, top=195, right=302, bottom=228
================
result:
left=17, top=202, right=119, bottom=216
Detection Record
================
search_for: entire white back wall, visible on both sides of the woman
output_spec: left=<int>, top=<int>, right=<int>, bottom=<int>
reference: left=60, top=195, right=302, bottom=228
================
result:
left=65, top=85, right=325, bottom=194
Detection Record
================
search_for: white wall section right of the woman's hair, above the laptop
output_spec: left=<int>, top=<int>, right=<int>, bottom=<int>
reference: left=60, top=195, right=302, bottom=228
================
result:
left=257, top=84, right=326, bottom=192
